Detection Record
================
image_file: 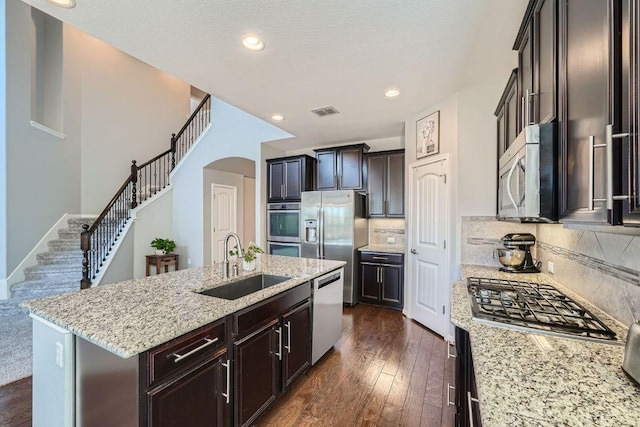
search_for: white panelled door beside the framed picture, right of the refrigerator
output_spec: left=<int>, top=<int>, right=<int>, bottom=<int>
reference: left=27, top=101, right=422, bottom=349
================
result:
left=408, top=157, right=451, bottom=336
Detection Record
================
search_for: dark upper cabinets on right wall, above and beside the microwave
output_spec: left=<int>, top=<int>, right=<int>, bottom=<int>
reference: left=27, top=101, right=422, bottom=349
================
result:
left=496, top=0, right=640, bottom=226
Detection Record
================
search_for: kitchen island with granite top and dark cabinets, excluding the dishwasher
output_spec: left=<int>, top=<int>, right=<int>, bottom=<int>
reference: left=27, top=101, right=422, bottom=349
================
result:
left=23, top=255, right=344, bottom=426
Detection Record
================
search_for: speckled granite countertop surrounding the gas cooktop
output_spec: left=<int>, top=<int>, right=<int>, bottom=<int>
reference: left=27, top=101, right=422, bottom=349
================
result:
left=451, top=265, right=640, bottom=426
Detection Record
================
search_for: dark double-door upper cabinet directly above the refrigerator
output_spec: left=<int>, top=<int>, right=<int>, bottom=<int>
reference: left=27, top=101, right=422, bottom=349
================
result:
left=314, top=144, right=369, bottom=190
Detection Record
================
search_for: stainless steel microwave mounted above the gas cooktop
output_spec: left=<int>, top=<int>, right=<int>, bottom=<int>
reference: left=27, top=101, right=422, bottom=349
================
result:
left=498, top=123, right=558, bottom=222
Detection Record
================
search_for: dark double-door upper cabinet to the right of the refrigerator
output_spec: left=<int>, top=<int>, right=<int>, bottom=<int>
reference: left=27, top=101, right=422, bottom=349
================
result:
left=366, top=150, right=404, bottom=218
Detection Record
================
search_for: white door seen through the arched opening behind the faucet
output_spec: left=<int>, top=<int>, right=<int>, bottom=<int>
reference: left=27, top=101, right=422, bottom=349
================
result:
left=211, top=184, right=238, bottom=264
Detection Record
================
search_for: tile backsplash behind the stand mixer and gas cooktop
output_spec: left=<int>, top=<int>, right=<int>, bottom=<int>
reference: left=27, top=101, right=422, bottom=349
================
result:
left=461, top=217, right=640, bottom=326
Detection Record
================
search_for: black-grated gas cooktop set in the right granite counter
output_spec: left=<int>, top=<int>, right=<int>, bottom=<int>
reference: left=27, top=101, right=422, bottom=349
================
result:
left=467, top=277, right=622, bottom=344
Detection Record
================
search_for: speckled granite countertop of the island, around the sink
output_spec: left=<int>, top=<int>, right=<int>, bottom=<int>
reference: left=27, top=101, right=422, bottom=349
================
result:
left=22, top=255, right=345, bottom=358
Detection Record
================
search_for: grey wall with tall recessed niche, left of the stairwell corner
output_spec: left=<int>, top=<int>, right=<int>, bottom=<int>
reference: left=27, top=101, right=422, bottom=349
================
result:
left=5, top=1, right=82, bottom=278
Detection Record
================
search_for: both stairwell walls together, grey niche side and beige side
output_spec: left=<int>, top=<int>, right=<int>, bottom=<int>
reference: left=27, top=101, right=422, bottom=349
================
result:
left=0, top=1, right=189, bottom=298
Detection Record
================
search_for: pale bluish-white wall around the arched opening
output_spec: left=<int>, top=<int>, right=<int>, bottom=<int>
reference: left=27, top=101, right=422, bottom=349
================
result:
left=172, top=98, right=291, bottom=267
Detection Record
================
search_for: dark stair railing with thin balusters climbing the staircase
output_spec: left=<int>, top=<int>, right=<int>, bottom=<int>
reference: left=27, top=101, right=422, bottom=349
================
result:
left=80, top=94, right=211, bottom=289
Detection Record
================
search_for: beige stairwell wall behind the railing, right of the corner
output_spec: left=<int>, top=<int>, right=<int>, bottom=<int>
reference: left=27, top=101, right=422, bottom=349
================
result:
left=73, top=29, right=190, bottom=213
